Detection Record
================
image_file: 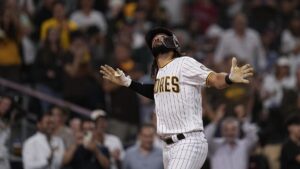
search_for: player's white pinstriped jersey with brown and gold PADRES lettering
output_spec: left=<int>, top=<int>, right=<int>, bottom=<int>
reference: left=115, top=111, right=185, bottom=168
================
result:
left=154, top=56, right=212, bottom=135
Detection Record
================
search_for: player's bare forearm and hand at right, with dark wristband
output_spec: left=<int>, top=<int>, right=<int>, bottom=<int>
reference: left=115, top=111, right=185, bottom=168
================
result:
left=207, top=57, right=254, bottom=89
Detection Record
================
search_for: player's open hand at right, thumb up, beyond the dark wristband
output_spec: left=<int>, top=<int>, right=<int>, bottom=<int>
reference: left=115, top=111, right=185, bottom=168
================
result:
left=229, top=57, right=254, bottom=83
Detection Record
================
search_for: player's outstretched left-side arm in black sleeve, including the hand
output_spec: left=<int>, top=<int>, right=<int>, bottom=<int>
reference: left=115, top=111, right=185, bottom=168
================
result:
left=100, top=65, right=154, bottom=100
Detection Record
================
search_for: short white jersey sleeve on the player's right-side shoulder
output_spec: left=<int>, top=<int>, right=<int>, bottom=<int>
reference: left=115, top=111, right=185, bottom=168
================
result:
left=182, top=57, right=213, bottom=86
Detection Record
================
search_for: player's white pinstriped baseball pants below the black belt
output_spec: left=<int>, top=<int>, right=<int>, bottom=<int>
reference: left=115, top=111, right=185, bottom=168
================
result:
left=163, top=132, right=208, bottom=169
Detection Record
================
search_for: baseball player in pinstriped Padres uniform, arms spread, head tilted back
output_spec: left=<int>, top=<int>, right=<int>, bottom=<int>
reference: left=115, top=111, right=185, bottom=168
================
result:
left=100, top=28, right=253, bottom=169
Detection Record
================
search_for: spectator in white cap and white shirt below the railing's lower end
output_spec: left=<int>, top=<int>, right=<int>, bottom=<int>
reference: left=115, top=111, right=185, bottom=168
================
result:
left=91, top=109, right=124, bottom=169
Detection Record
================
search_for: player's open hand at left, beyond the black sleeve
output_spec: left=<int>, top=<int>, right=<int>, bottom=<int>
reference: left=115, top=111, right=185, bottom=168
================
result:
left=100, top=65, right=131, bottom=87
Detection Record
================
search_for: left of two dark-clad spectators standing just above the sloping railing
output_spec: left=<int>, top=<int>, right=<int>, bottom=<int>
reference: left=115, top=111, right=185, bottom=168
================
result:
left=33, top=28, right=66, bottom=112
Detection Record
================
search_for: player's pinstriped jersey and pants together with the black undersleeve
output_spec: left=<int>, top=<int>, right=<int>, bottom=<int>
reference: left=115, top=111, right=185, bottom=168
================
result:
left=129, top=56, right=212, bottom=169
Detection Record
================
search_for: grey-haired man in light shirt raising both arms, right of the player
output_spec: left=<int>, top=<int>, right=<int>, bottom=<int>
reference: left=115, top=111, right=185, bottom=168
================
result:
left=205, top=109, right=258, bottom=169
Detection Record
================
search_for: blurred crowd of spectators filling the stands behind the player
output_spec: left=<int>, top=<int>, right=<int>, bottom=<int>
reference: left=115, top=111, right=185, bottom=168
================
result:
left=0, top=0, right=300, bottom=169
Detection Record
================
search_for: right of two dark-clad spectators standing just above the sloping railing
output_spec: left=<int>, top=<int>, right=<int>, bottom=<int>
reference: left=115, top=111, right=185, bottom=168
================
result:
left=63, top=31, right=104, bottom=108
